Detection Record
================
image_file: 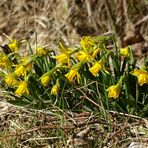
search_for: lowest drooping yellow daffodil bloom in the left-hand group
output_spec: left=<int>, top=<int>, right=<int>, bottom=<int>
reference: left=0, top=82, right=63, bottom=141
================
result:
left=15, top=81, right=29, bottom=96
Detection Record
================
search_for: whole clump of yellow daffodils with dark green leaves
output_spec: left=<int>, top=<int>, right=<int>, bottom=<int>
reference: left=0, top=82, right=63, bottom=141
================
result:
left=0, top=36, right=148, bottom=114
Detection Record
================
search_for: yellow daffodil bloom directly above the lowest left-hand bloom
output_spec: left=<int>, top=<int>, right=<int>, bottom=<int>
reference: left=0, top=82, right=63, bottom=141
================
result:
left=14, top=65, right=27, bottom=77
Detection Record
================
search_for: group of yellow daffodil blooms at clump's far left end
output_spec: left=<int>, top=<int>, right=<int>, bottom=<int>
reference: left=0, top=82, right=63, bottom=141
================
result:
left=0, top=40, right=37, bottom=96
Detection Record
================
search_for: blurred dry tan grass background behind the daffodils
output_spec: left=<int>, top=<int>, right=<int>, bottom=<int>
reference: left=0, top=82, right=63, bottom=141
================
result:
left=0, top=0, right=148, bottom=56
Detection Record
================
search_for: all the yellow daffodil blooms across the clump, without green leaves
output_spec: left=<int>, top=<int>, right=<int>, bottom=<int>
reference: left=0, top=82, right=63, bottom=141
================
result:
left=0, top=36, right=148, bottom=99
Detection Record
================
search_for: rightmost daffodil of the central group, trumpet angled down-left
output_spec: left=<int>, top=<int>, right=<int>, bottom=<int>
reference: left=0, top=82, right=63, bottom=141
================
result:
left=89, top=60, right=104, bottom=77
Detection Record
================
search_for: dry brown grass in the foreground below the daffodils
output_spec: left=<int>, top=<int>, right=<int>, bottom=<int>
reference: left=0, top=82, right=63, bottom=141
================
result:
left=0, top=103, right=148, bottom=148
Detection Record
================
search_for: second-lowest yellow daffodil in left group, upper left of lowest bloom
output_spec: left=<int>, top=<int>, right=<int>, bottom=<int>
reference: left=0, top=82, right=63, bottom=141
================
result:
left=5, top=74, right=19, bottom=87
